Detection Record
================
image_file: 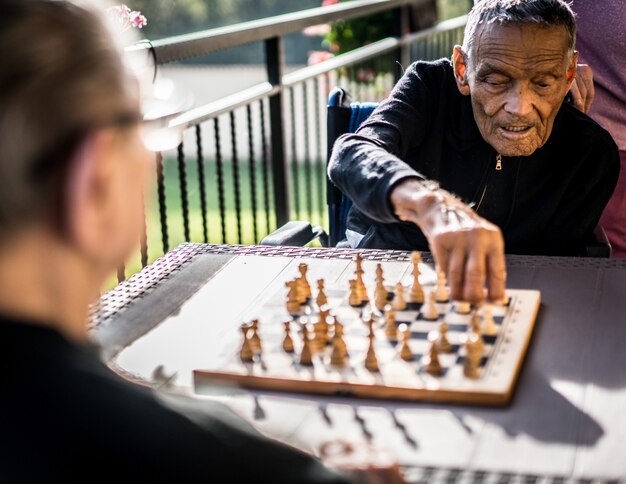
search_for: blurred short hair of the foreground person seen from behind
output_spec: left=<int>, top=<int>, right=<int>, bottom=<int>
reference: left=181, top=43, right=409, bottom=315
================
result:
left=0, top=0, right=138, bottom=234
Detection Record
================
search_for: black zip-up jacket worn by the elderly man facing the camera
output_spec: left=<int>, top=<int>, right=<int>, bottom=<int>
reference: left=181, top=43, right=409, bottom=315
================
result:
left=329, top=59, right=619, bottom=255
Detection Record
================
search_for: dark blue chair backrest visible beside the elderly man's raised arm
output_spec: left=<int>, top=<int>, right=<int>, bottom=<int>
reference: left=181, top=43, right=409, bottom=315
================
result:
left=327, top=87, right=378, bottom=247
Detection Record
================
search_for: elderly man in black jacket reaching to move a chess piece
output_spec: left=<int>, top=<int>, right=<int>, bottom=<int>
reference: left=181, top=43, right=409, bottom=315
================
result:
left=329, top=0, right=619, bottom=301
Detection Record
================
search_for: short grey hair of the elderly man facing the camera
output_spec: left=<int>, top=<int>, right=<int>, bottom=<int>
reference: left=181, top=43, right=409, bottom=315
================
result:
left=463, top=0, right=576, bottom=55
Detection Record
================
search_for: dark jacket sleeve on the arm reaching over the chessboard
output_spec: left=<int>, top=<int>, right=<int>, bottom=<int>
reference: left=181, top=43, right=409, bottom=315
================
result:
left=328, top=63, right=433, bottom=223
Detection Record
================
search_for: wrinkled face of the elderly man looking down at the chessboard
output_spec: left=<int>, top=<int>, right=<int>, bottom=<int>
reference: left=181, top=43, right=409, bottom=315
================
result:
left=454, top=24, right=577, bottom=156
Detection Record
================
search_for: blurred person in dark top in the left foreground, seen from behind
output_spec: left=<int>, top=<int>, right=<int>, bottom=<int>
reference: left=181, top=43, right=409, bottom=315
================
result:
left=0, top=0, right=360, bottom=483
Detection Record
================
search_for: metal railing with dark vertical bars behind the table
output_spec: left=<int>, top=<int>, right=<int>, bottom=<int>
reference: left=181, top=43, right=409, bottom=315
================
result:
left=118, top=0, right=466, bottom=278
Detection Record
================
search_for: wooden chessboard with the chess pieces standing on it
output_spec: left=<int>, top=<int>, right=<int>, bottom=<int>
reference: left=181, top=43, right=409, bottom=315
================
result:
left=193, top=253, right=540, bottom=405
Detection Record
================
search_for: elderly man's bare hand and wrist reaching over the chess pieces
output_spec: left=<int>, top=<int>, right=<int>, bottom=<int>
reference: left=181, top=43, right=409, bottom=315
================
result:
left=391, top=179, right=506, bottom=303
